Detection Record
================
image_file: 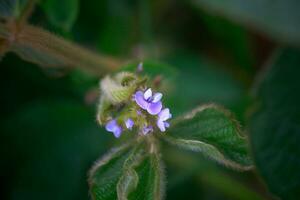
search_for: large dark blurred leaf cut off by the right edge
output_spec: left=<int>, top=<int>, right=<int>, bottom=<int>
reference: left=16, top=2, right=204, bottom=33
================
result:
left=249, top=49, right=300, bottom=199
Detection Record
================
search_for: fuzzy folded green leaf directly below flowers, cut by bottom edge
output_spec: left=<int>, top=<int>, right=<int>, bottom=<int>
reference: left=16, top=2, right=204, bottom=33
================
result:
left=89, top=143, right=164, bottom=200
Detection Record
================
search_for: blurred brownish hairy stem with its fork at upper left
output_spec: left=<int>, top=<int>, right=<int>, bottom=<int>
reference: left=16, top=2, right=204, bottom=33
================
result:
left=0, top=0, right=121, bottom=75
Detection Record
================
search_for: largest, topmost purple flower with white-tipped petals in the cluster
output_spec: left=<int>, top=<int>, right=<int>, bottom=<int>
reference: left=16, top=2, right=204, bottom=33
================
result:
left=134, top=88, right=162, bottom=115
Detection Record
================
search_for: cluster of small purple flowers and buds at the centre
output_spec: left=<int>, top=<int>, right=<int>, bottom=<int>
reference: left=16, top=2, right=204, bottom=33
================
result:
left=105, top=88, right=172, bottom=138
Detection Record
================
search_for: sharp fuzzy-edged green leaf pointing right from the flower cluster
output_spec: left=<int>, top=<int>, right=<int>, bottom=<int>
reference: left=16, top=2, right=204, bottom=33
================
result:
left=165, top=104, right=251, bottom=170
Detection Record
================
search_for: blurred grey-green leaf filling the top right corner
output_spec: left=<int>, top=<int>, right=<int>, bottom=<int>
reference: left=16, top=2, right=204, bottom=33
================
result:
left=190, top=0, right=300, bottom=45
